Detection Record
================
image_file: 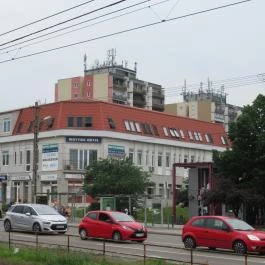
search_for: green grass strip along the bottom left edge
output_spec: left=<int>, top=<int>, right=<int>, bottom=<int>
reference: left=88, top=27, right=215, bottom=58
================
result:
left=0, top=244, right=187, bottom=265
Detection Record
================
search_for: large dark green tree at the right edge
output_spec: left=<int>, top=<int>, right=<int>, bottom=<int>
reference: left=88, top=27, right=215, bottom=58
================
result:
left=205, top=95, right=265, bottom=222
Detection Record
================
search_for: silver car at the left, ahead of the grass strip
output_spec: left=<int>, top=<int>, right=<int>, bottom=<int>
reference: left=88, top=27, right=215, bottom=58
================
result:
left=4, top=204, right=67, bottom=234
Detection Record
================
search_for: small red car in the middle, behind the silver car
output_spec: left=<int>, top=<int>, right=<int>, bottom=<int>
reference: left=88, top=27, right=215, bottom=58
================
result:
left=79, top=211, right=147, bottom=242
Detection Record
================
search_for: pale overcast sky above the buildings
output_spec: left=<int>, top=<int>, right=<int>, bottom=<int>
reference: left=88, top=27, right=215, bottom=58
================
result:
left=0, top=0, right=265, bottom=112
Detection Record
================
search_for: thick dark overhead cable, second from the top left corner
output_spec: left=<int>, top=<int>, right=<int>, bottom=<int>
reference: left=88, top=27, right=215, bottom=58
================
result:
left=0, top=0, right=128, bottom=46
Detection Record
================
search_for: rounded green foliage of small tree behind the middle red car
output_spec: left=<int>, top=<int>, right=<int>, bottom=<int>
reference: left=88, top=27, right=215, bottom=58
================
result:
left=84, top=158, right=149, bottom=197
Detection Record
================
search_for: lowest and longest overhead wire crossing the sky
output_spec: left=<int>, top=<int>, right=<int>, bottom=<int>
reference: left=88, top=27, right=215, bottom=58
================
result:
left=0, top=0, right=252, bottom=63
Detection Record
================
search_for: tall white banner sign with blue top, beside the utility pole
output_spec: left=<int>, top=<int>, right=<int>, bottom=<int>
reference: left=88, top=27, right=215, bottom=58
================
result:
left=42, top=144, right=59, bottom=171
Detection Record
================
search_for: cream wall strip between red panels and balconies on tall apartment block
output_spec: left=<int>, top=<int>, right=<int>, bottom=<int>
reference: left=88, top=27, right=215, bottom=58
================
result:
left=93, top=73, right=109, bottom=100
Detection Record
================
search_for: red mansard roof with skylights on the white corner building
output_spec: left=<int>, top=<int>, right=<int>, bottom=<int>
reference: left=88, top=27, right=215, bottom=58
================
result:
left=13, top=100, right=227, bottom=147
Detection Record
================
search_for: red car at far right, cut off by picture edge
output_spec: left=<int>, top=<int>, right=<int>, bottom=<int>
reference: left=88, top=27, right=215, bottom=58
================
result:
left=182, top=216, right=265, bottom=254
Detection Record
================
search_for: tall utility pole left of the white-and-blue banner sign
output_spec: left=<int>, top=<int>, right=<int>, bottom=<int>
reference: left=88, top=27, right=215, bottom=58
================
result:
left=31, top=101, right=39, bottom=203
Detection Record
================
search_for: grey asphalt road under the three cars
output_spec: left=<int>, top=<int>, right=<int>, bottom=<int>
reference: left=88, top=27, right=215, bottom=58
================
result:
left=0, top=221, right=265, bottom=265
